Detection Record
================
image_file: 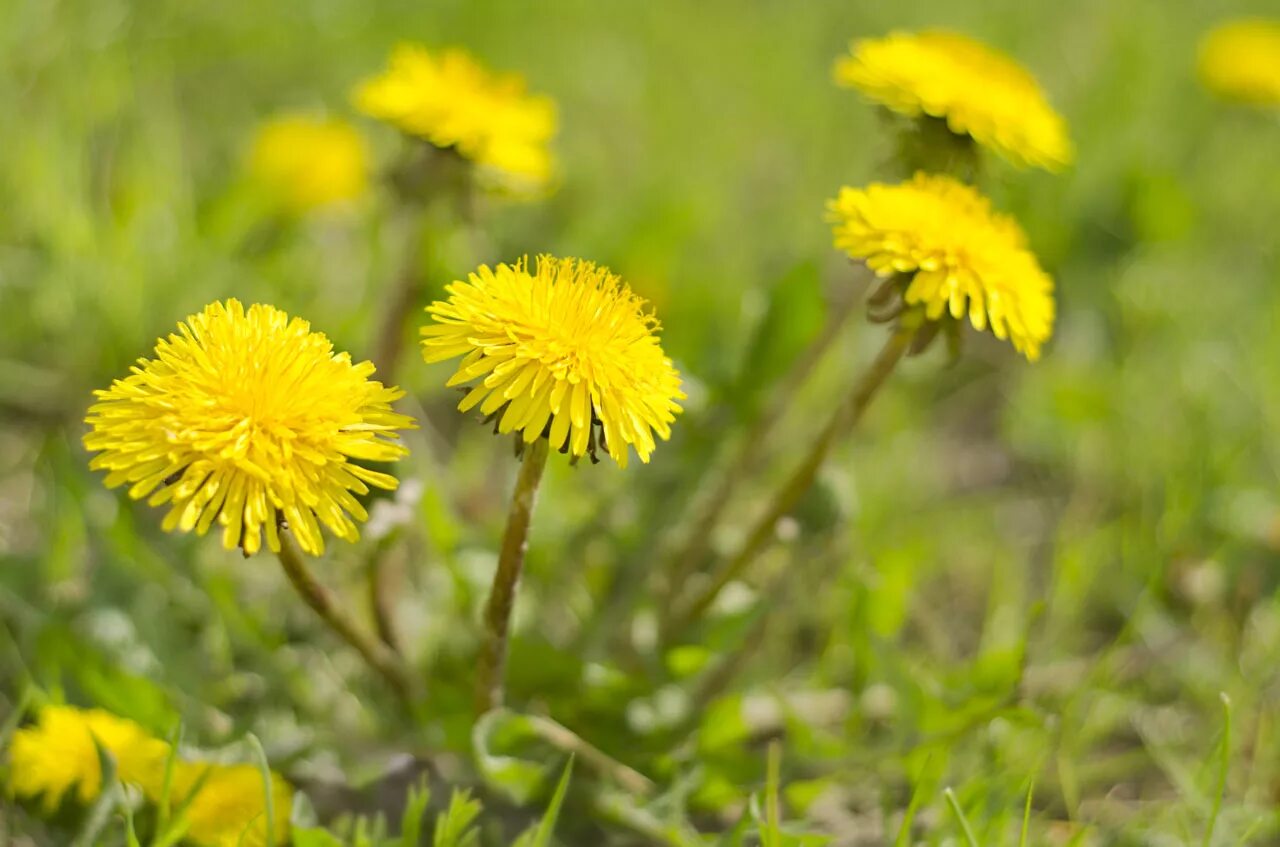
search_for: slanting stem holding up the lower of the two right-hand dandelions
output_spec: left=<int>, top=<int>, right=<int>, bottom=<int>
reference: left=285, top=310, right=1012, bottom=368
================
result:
left=663, top=321, right=918, bottom=635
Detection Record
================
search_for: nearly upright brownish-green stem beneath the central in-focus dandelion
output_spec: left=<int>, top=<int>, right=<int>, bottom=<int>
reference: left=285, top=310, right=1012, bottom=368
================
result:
left=476, top=438, right=549, bottom=714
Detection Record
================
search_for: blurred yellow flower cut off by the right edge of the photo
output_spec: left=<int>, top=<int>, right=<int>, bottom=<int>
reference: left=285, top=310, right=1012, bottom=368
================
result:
left=1199, top=18, right=1280, bottom=106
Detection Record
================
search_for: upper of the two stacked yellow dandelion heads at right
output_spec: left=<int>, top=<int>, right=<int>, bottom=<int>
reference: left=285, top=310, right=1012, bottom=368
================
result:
left=835, top=31, right=1074, bottom=170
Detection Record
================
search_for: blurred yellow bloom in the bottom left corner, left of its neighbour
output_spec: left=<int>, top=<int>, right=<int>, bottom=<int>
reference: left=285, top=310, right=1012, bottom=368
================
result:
left=9, top=706, right=169, bottom=811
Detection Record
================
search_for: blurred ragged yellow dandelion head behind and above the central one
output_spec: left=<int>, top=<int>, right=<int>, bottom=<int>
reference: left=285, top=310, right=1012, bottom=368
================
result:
left=355, top=45, right=556, bottom=191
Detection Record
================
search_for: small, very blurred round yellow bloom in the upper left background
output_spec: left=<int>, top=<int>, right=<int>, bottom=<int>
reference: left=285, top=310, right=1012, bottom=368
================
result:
left=248, top=114, right=369, bottom=214
